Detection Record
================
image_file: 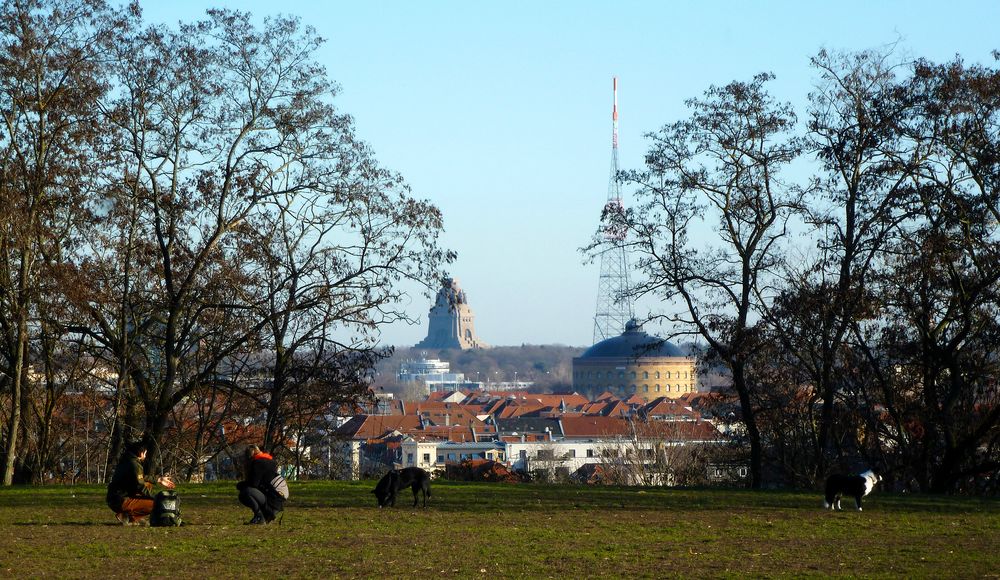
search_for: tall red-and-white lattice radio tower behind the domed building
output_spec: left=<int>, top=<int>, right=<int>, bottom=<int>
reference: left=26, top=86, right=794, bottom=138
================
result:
left=594, top=77, right=634, bottom=344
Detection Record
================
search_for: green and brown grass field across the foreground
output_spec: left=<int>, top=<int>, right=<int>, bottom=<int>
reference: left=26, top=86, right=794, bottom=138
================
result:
left=0, top=482, right=1000, bottom=580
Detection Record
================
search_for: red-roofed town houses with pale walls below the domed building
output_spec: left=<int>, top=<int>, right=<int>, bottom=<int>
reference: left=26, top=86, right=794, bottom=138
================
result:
left=328, top=391, right=736, bottom=484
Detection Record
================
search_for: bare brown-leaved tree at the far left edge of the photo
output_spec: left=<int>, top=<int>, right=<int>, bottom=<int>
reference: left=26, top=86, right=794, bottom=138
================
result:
left=0, top=0, right=114, bottom=485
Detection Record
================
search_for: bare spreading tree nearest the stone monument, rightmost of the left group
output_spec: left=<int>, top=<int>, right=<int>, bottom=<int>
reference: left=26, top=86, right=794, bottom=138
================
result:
left=235, top=133, right=451, bottom=448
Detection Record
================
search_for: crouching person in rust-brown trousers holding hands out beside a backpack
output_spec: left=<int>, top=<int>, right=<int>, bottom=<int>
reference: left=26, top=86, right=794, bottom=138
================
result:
left=105, top=441, right=174, bottom=526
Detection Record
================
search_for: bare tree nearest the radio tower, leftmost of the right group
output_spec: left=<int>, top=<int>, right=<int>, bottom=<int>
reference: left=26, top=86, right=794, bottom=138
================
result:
left=609, top=74, right=801, bottom=487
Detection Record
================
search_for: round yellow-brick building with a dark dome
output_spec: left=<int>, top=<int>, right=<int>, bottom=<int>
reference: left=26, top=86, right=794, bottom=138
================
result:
left=573, top=320, right=698, bottom=400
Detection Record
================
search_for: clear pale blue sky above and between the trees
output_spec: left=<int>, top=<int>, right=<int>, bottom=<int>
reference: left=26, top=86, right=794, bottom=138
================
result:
left=141, top=0, right=1000, bottom=346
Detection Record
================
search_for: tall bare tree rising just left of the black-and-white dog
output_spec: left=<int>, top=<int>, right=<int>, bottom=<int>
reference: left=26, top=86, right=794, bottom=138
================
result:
left=772, top=50, right=923, bottom=479
